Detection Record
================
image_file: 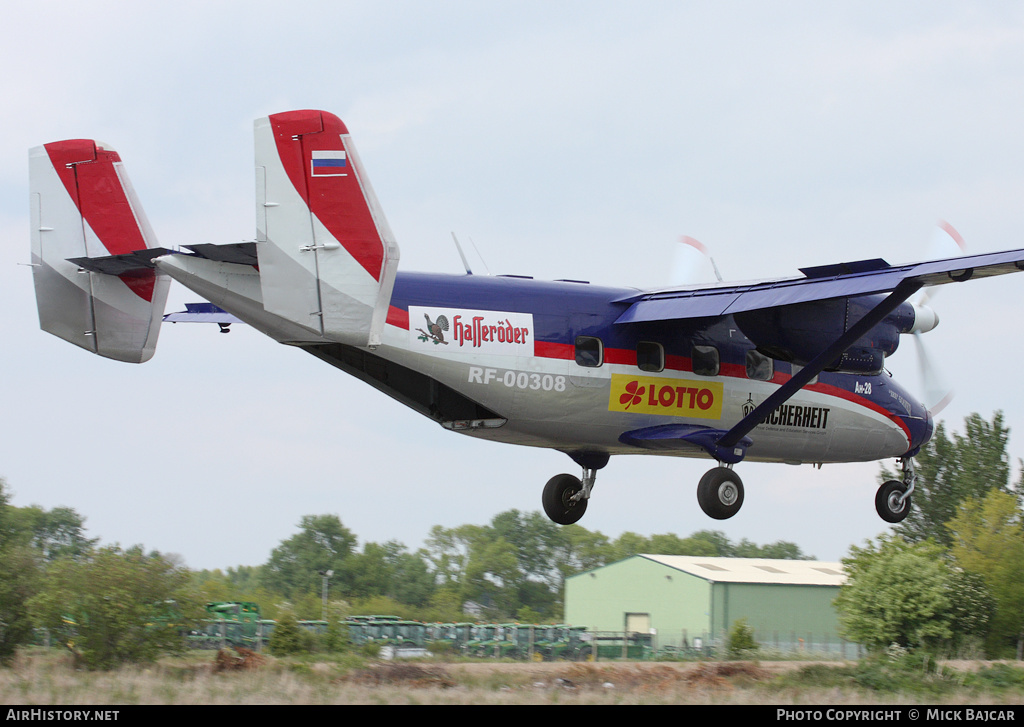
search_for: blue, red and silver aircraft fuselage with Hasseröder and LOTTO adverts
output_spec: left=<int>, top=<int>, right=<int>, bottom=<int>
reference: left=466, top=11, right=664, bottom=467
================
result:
left=174, top=264, right=932, bottom=463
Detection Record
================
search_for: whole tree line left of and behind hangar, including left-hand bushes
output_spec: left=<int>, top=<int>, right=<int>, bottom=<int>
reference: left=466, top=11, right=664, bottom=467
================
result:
left=0, top=479, right=810, bottom=669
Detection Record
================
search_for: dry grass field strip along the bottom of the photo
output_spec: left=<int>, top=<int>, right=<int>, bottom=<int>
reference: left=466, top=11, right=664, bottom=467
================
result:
left=0, top=651, right=1024, bottom=705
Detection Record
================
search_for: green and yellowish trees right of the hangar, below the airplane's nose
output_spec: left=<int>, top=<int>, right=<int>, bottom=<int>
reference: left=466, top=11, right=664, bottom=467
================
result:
left=836, top=412, right=1024, bottom=659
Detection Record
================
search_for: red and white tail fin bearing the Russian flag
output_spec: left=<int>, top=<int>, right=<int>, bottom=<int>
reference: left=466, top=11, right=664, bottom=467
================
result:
left=255, top=111, right=398, bottom=346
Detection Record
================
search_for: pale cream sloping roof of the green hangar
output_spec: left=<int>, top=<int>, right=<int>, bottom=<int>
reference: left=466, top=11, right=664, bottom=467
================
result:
left=639, top=554, right=846, bottom=586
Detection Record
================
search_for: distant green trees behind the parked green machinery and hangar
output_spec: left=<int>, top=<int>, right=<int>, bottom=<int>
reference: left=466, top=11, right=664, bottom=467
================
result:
left=195, top=510, right=810, bottom=623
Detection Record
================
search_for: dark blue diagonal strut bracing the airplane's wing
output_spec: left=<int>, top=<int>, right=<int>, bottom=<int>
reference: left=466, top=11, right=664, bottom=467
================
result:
left=717, top=279, right=923, bottom=448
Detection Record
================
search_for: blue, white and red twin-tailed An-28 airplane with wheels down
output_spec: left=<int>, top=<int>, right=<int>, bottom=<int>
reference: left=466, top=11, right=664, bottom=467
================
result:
left=30, top=110, right=1024, bottom=524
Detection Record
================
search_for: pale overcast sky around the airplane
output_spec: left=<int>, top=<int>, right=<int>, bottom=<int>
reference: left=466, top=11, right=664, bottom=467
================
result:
left=0, top=0, right=1024, bottom=568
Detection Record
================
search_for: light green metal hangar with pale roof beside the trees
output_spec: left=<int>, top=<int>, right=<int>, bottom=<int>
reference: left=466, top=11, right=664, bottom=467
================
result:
left=565, top=555, right=856, bottom=656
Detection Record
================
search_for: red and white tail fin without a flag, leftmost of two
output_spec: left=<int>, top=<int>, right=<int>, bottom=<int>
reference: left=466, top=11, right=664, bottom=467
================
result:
left=29, top=139, right=170, bottom=364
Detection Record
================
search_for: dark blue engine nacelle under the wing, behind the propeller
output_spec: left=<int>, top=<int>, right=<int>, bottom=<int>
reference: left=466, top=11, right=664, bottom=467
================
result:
left=733, top=295, right=925, bottom=374
